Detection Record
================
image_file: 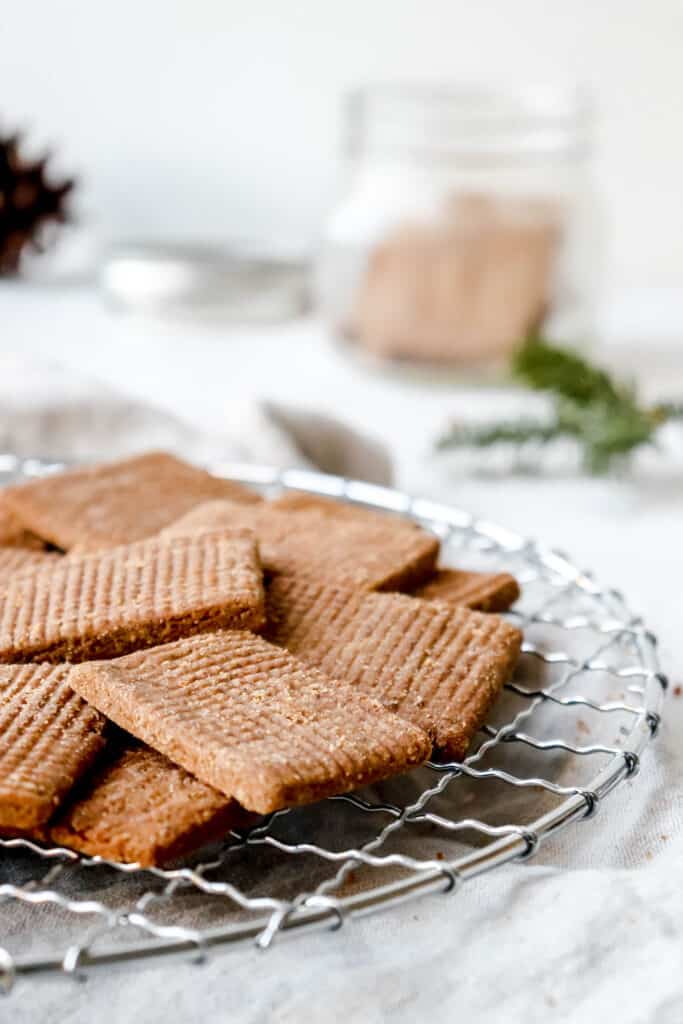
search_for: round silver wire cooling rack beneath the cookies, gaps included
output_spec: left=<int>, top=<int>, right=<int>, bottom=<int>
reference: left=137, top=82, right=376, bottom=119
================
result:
left=0, top=456, right=667, bottom=989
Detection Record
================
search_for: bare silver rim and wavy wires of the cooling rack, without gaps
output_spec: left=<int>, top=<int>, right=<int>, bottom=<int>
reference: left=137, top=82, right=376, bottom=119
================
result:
left=0, top=455, right=667, bottom=990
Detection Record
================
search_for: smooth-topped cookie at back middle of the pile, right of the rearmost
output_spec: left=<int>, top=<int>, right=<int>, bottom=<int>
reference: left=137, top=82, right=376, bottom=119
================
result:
left=164, top=496, right=439, bottom=590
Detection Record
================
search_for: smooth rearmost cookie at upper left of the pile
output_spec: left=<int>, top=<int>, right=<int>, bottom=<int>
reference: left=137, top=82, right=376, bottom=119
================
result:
left=4, top=452, right=261, bottom=551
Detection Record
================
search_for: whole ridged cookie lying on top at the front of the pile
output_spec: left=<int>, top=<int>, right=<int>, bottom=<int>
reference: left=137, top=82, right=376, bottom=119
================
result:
left=69, top=630, right=430, bottom=814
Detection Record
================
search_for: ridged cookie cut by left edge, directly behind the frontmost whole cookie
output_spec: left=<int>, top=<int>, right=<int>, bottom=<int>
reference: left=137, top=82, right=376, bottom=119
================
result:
left=0, top=530, right=263, bottom=662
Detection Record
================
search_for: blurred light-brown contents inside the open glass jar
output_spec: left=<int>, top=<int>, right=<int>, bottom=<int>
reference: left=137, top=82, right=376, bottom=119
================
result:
left=351, top=195, right=560, bottom=364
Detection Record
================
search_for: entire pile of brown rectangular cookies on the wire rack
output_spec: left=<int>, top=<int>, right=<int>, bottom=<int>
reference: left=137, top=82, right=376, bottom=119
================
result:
left=0, top=453, right=521, bottom=866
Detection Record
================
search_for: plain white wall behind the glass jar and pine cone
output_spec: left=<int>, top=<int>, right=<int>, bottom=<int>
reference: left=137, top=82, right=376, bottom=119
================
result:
left=0, top=0, right=683, bottom=289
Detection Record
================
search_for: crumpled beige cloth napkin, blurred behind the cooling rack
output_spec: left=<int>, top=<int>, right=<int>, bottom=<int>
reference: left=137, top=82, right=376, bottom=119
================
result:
left=0, top=355, right=392, bottom=484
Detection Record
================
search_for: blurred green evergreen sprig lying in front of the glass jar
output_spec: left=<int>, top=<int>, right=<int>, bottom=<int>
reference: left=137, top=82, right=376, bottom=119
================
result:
left=437, top=335, right=683, bottom=474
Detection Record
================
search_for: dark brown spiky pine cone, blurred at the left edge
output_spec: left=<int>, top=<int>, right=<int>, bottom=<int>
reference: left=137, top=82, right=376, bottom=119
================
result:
left=0, top=135, right=74, bottom=275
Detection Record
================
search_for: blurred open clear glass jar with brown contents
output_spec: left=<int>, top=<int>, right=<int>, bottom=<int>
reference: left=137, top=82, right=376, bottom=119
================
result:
left=316, top=86, right=599, bottom=366
